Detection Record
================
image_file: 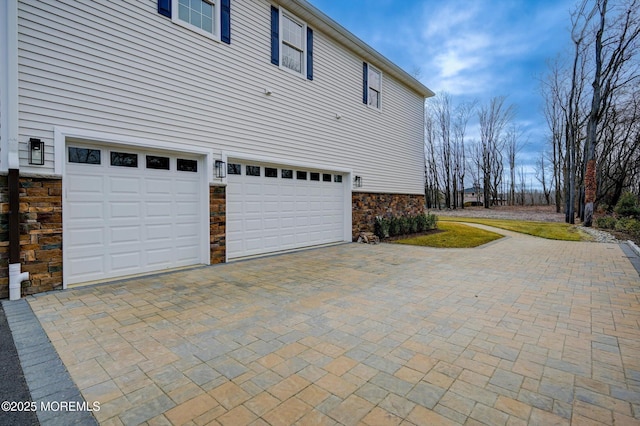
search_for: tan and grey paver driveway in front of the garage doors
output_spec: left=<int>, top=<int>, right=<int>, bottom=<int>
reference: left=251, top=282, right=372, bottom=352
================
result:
left=30, top=231, right=640, bottom=425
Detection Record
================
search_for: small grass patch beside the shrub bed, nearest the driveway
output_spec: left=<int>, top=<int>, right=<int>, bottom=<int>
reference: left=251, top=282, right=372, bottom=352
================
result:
left=394, top=222, right=502, bottom=248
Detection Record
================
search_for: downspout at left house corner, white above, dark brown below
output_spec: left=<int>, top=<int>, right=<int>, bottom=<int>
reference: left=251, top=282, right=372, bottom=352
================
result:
left=0, top=0, right=29, bottom=300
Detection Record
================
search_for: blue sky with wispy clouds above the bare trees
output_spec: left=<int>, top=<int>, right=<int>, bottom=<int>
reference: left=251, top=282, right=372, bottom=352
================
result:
left=310, top=0, right=576, bottom=179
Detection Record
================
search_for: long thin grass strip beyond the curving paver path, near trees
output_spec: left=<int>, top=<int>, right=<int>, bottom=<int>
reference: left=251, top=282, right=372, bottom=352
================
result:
left=438, top=216, right=588, bottom=241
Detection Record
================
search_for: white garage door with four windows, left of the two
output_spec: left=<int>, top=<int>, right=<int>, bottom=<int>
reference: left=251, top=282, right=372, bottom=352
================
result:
left=63, top=144, right=208, bottom=284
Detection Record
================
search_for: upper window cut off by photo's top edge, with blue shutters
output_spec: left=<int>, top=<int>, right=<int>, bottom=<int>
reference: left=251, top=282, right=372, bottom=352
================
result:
left=158, top=0, right=231, bottom=43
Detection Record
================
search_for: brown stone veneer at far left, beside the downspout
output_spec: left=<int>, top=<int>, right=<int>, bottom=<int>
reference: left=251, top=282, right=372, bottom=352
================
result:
left=0, top=176, right=62, bottom=299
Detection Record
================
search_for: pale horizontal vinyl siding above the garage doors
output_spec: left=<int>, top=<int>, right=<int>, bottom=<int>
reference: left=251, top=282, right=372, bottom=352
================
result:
left=19, top=0, right=424, bottom=194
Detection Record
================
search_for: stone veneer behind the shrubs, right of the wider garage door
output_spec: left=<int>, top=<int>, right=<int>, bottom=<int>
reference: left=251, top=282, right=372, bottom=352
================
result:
left=351, top=192, right=426, bottom=241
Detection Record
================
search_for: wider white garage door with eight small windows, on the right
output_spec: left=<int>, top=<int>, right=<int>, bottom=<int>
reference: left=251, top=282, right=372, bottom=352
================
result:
left=227, top=161, right=350, bottom=259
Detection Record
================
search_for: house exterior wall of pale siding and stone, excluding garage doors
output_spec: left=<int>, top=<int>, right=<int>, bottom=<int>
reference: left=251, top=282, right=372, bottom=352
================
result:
left=0, top=0, right=429, bottom=298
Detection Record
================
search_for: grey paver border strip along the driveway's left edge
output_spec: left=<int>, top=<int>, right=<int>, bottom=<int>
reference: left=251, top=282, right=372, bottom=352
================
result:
left=2, top=299, right=98, bottom=426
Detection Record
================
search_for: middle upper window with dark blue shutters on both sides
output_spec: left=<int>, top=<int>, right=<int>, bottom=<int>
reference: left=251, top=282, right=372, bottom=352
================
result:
left=271, top=6, right=313, bottom=80
